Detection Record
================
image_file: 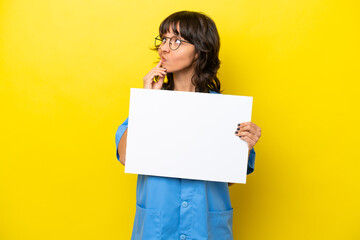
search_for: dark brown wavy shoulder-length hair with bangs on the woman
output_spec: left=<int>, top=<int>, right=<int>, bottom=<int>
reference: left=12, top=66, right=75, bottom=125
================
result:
left=152, top=11, right=222, bottom=93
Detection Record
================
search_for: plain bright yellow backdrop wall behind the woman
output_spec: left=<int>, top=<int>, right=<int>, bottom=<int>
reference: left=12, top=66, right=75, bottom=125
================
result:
left=0, top=0, right=360, bottom=240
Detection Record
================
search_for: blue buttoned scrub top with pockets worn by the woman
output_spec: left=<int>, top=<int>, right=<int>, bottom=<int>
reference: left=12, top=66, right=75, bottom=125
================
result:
left=115, top=91, right=255, bottom=240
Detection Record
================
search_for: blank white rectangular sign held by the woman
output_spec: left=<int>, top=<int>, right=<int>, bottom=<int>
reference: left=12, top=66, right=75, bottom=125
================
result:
left=125, top=88, right=253, bottom=183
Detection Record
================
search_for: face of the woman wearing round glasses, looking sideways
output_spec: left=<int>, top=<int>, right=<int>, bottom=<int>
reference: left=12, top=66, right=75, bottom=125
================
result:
left=158, top=25, right=196, bottom=73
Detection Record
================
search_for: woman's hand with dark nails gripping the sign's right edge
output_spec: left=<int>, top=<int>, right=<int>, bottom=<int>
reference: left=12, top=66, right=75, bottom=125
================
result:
left=235, top=122, right=261, bottom=150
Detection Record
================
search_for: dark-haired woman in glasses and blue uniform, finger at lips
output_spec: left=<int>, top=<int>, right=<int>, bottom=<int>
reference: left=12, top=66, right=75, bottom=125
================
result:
left=116, top=11, right=261, bottom=240
